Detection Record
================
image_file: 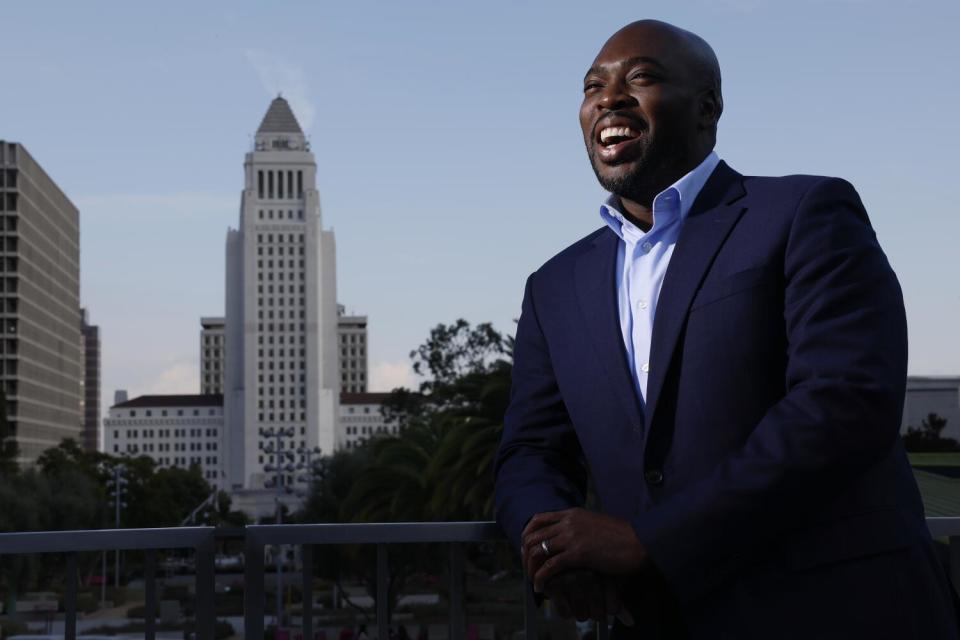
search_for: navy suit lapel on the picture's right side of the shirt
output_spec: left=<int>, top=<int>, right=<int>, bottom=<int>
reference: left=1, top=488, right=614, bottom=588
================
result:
left=645, top=162, right=746, bottom=433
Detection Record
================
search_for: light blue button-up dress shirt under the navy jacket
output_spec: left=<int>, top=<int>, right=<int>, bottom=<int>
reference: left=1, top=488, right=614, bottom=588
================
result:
left=600, top=152, right=720, bottom=406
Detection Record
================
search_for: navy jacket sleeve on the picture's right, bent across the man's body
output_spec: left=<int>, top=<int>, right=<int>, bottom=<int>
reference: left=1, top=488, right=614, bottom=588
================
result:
left=632, top=178, right=907, bottom=602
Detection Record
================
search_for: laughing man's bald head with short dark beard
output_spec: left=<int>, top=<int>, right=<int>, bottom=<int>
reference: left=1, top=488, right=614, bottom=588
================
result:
left=580, top=21, right=721, bottom=206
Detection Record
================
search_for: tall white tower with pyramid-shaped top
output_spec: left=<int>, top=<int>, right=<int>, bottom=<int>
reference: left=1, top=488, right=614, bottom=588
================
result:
left=224, top=97, right=340, bottom=490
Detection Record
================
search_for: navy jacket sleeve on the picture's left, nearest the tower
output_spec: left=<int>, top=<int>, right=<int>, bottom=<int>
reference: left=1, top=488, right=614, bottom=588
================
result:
left=494, top=274, right=587, bottom=550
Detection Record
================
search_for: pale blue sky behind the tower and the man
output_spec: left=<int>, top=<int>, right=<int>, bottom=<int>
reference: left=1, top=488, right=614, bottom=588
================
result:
left=0, top=0, right=960, bottom=410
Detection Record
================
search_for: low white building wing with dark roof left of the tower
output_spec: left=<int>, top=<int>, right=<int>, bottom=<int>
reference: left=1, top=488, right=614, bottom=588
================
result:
left=103, top=394, right=227, bottom=489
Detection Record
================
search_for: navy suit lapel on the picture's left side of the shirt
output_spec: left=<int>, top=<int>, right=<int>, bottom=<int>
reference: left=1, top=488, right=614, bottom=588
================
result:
left=574, top=230, right=643, bottom=428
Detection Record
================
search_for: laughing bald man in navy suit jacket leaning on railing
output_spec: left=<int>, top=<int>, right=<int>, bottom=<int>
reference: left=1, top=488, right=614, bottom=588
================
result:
left=496, top=21, right=957, bottom=639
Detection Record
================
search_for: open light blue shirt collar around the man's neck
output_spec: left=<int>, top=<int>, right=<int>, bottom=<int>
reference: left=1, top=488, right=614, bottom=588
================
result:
left=600, top=151, right=720, bottom=242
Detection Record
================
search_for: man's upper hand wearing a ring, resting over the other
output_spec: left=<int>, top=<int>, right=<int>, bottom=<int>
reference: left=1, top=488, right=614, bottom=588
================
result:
left=521, top=507, right=647, bottom=593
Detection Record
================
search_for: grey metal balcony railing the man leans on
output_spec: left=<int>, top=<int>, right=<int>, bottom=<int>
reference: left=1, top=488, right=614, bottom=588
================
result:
left=0, top=517, right=960, bottom=640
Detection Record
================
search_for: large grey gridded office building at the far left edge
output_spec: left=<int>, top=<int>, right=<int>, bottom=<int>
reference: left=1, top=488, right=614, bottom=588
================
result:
left=0, top=140, right=83, bottom=465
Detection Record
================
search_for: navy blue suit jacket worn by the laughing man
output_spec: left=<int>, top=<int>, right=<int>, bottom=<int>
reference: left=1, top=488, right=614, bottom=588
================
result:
left=496, top=163, right=956, bottom=638
